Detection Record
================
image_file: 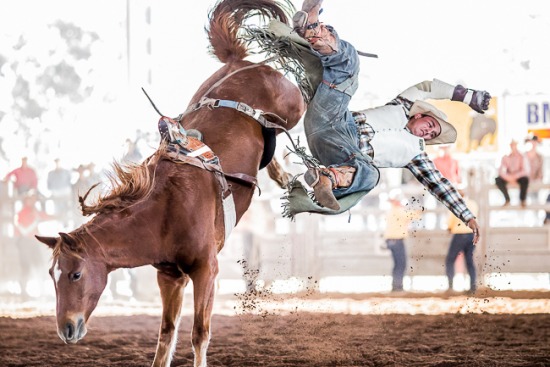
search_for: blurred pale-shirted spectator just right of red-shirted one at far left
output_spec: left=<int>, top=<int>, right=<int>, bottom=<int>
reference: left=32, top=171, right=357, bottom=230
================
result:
left=48, top=158, right=74, bottom=220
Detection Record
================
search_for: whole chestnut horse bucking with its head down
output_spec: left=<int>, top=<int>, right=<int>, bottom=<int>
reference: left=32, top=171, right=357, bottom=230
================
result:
left=37, top=0, right=305, bottom=366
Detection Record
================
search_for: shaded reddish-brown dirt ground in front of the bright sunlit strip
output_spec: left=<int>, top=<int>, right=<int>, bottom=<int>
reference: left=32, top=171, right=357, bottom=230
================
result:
left=0, top=292, right=550, bottom=367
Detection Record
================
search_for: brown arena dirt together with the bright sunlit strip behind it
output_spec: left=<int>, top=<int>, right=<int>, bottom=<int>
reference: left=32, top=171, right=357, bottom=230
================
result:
left=0, top=291, right=550, bottom=367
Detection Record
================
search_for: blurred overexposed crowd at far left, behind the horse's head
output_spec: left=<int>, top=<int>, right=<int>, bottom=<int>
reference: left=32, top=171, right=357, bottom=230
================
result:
left=0, top=131, right=156, bottom=299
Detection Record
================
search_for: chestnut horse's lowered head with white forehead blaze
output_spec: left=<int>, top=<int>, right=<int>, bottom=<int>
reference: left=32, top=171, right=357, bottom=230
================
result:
left=36, top=233, right=109, bottom=344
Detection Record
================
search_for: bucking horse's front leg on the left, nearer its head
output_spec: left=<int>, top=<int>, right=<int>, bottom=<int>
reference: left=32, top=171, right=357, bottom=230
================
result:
left=153, top=270, right=189, bottom=367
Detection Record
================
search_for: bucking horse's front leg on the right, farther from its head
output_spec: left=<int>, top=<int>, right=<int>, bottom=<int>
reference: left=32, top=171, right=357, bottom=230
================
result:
left=190, top=255, right=218, bottom=367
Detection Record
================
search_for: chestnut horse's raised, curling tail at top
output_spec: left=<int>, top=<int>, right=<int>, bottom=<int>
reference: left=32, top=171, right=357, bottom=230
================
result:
left=206, top=0, right=294, bottom=64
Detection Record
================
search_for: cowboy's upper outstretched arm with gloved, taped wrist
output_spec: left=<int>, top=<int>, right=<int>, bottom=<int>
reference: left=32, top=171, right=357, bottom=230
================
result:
left=399, top=79, right=491, bottom=113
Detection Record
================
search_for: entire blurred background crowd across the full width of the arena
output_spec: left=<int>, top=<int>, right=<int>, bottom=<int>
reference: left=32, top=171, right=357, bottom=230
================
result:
left=0, top=123, right=550, bottom=299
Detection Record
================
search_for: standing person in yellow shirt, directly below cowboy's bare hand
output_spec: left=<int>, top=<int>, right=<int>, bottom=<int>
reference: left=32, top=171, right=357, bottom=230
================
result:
left=445, top=190, right=478, bottom=294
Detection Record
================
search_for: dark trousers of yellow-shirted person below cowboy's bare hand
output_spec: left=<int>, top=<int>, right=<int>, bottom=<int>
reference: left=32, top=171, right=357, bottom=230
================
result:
left=445, top=233, right=477, bottom=292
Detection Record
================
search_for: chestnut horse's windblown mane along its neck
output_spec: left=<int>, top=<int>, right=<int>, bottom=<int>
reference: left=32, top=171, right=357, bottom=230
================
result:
left=78, top=144, right=166, bottom=216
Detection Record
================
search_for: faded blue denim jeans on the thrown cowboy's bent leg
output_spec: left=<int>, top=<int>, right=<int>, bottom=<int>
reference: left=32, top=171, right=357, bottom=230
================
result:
left=304, top=79, right=380, bottom=198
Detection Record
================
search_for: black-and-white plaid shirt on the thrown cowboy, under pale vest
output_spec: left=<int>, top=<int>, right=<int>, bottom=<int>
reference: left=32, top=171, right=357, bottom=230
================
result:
left=352, top=97, right=475, bottom=223
